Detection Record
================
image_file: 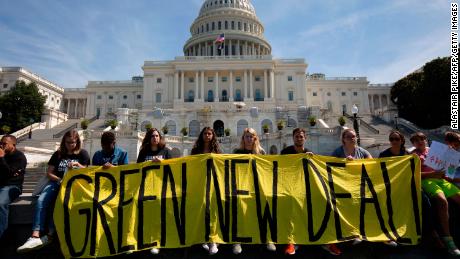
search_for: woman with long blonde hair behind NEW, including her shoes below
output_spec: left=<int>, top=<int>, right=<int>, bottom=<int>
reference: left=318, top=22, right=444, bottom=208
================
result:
left=232, top=128, right=276, bottom=255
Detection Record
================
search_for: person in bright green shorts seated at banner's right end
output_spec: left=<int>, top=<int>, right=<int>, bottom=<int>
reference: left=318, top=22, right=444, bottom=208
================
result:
left=410, top=132, right=460, bottom=256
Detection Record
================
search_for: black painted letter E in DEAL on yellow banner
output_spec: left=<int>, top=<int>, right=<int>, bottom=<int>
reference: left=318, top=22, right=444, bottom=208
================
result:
left=326, top=163, right=357, bottom=241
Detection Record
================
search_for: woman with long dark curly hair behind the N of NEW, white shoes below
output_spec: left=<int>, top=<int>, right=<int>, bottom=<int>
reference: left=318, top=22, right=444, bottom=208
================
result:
left=191, top=127, right=222, bottom=255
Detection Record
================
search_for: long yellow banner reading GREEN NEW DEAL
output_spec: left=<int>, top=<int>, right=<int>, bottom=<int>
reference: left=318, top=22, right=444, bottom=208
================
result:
left=54, top=154, right=421, bottom=257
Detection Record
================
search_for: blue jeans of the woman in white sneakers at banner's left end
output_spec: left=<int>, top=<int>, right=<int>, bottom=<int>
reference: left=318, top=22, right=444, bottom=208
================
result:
left=32, top=182, right=60, bottom=234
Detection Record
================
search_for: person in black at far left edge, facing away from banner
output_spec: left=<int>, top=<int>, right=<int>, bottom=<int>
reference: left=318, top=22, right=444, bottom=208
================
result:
left=0, top=135, right=27, bottom=237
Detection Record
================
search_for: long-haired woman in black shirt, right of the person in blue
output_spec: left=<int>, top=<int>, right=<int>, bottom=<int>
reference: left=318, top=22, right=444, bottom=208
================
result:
left=137, top=128, right=172, bottom=163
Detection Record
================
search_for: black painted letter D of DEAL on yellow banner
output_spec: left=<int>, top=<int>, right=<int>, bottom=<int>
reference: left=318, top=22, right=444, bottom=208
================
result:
left=302, top=158, right=332, bottom=242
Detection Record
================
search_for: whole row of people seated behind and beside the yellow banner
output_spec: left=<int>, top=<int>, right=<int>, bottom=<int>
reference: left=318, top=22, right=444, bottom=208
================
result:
left=0, top=127, right=460, bottom=256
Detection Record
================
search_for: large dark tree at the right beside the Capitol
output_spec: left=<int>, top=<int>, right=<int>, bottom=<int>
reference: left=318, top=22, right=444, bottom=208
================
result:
left=391, top=57, right=450, bottom=129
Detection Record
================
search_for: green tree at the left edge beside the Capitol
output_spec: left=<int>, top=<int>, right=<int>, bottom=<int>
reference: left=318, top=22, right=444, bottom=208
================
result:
left=0, top=81, right=46, bottom=132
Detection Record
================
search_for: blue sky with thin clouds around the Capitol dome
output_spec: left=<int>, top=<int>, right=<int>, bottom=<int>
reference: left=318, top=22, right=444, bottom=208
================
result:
left=0, top=0, right=450, bottom=88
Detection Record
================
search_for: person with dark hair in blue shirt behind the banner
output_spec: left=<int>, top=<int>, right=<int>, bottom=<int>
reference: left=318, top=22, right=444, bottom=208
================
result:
left=93, top=131, right=128, bottom=169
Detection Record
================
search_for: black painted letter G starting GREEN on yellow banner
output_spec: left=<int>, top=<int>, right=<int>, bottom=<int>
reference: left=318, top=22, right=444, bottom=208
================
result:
left=63, top=175, right=93, bottom=257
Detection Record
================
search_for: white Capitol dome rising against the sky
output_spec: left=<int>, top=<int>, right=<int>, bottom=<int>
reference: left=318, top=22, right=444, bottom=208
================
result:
left=184, top=0, right=271, bottom=56
